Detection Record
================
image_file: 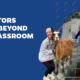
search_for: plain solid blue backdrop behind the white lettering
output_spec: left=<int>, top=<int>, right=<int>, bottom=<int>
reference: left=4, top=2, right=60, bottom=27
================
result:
left=0, top=0, right=80, bottom=80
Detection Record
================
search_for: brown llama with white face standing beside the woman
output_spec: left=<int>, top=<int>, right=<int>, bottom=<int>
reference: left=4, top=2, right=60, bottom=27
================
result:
left=51, top=27, right=74, bottom=74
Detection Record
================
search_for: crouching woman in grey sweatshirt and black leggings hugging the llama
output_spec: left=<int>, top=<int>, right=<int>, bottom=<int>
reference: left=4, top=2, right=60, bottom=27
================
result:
left=39, top=28, right=55, bottom=80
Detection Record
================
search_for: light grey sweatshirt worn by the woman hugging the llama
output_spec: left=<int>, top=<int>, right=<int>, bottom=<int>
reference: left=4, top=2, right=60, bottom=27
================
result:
left=39, top=37, right=54, bottom=62
